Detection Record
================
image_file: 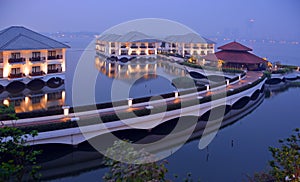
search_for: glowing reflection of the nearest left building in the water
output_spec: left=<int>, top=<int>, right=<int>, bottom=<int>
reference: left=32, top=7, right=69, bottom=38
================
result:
left=0, top=84, right=66, bottom=113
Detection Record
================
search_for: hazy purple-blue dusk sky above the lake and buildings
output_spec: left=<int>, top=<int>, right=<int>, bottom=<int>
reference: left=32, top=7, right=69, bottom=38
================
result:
left=0, top=0, right=300, bottom=41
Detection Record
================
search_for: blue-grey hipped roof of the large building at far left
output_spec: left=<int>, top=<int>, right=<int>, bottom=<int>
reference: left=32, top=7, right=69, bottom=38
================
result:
left=0, top=26, right=69, bottom=51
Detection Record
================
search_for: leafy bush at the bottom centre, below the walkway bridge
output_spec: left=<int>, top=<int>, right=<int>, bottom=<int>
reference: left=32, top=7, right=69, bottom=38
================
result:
left=103, top=141, right=169, bottom=182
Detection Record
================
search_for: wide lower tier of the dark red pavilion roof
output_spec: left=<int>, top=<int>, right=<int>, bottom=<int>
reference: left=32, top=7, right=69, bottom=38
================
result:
left=215, top=50, right=265, bottom=64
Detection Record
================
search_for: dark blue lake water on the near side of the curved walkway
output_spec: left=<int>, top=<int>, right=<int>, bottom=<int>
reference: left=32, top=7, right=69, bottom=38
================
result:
left=34, top=85, right=300, bottom=181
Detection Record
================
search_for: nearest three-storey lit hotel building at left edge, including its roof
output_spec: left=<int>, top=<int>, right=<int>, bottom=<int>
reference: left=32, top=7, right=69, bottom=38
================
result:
left=0, top=26, right=69, bottom=86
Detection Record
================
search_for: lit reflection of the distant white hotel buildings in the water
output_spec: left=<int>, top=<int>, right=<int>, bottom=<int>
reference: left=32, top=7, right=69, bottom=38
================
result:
left=95, top=55, right=186, bottom=80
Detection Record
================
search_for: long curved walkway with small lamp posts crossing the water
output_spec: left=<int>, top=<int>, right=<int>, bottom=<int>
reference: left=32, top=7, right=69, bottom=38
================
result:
left=0, top=71, right=263, bottom=127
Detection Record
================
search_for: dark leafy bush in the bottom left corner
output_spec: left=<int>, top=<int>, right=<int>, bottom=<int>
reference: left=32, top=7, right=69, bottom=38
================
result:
left=0, top=104, right=41, bottom=181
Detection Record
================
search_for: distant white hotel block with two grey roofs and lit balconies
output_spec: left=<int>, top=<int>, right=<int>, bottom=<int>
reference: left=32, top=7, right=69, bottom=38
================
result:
left=96, top=31, right=215, bottom=59
